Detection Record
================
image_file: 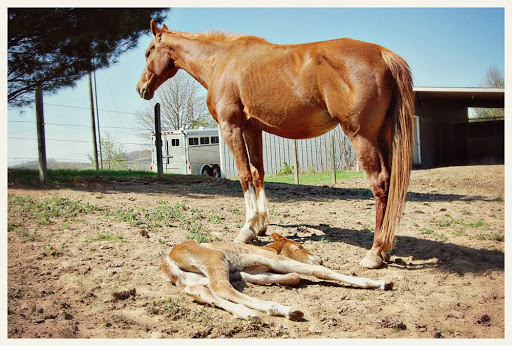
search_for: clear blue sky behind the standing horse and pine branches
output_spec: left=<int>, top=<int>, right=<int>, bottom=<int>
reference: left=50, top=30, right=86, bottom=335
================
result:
left=8, top=8, right=505, bottom=166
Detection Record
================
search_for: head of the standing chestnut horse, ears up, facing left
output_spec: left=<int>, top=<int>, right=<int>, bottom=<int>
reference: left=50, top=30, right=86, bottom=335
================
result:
left=137, top=19, right=178, bottom=100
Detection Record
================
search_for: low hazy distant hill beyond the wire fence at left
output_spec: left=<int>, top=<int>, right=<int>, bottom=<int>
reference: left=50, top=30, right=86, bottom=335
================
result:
left=9, top=150, right=151, bottom=170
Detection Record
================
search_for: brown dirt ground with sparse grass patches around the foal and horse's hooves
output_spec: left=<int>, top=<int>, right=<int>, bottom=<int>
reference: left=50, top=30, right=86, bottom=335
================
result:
left=8, top=165, right=505, bottom=338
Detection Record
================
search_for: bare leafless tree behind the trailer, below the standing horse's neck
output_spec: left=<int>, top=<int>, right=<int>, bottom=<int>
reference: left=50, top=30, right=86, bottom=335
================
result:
left=139, top=72, right=217, bottom=137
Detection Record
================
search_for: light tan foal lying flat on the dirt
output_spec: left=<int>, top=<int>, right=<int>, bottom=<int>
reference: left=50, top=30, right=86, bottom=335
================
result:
left=161, top=233, right=392, bottom=321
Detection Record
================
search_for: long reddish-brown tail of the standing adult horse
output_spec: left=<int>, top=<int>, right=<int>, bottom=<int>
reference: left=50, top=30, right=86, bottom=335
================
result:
left=377, top=49, right=414, bottom=253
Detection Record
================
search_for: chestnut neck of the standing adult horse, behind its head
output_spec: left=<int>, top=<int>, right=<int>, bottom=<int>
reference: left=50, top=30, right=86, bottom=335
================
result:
left=164, top=33, right=219, bottom=89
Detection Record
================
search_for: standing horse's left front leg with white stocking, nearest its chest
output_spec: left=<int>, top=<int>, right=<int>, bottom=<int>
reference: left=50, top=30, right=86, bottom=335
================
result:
left=219, top=117, right=261, bottom=243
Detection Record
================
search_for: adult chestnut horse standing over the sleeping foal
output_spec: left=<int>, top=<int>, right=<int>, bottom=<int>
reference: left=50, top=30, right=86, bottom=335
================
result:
left=137, top=21, right=414, bottom=268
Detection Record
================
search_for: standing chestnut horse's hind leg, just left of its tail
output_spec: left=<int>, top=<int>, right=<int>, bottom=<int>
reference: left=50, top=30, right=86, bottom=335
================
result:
left=352, top=135, right=390, bottom=268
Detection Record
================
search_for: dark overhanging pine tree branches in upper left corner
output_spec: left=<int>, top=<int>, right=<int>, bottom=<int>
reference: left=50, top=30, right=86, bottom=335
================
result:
left=8, top=8, right=169, bottom=107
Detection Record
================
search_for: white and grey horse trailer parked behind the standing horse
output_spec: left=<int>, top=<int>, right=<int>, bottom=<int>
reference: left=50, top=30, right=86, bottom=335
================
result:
left=151, top=129, right=221, bottom=177
